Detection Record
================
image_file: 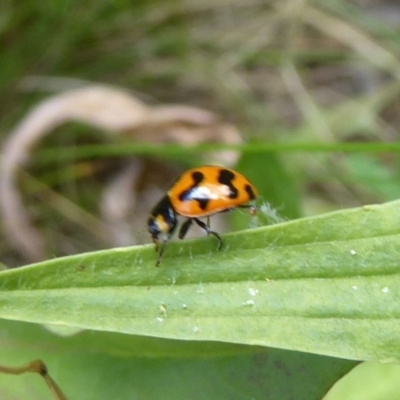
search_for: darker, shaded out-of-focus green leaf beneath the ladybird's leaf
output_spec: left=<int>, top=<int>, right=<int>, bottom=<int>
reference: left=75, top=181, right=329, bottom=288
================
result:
left=0, top=320, right=356, bottom=400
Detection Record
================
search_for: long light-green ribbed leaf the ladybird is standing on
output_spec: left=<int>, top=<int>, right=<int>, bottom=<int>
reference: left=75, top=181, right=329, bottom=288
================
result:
left=0, top=201, right=400, bottom=361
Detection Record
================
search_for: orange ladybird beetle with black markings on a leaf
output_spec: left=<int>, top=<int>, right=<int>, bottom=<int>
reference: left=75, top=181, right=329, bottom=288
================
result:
left=147, top=166, right=258, bottom=267
